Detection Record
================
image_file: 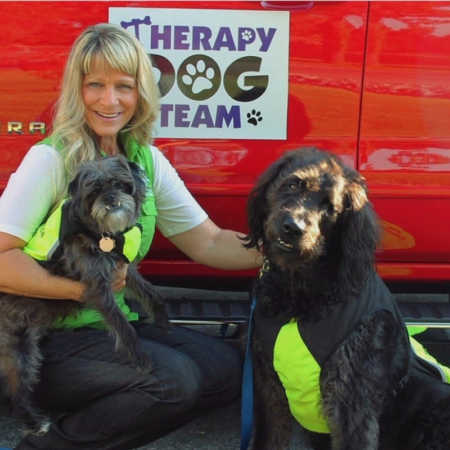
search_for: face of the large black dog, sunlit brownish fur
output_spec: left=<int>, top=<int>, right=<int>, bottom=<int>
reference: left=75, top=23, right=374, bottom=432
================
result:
left=264, top=153, right=367, bottom=268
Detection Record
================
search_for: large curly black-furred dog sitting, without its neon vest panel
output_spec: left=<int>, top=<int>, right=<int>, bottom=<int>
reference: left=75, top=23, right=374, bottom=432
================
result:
left=245, top=148, right=450, bottom=450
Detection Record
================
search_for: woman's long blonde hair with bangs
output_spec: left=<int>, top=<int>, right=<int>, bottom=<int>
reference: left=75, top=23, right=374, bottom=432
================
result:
left=52, top=24, right=159, bottom=180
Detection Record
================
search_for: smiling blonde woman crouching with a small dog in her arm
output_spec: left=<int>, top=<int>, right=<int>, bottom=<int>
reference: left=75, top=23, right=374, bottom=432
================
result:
left=0, top=24, right=259, bottom=450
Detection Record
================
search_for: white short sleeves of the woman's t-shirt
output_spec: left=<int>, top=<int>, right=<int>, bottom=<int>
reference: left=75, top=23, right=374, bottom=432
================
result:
left=0, top=144, right=208, bottom=241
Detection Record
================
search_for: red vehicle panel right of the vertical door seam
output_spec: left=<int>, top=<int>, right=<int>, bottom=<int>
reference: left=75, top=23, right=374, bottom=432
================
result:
left=359, top=2, right=450, bottom=280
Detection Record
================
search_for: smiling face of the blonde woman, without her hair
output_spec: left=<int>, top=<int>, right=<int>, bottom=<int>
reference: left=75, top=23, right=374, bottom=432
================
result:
left=82, top=60, right=138, bottom=146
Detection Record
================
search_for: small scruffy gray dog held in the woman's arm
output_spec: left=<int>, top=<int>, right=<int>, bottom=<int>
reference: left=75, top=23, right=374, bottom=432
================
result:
left=0, top=156, right=168, bottom=434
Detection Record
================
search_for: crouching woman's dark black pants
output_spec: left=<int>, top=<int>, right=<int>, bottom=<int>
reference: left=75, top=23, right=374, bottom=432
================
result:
left=16, top=323, right=241, bottom=450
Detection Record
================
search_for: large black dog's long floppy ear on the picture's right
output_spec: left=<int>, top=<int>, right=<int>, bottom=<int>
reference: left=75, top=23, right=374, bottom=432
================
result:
left=336, top=169, right=379, bottom=293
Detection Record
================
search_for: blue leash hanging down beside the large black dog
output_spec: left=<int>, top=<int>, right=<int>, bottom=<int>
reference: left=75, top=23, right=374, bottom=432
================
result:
left=241, top=295, right=256, bottom=450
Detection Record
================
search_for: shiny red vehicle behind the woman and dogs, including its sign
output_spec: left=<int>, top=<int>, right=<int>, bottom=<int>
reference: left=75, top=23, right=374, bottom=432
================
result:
left=0, top=0, right=450, bottom=330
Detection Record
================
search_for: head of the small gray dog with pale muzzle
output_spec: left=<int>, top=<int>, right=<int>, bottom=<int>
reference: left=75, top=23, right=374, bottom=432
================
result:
left=69, top=156, right=146, bottom=234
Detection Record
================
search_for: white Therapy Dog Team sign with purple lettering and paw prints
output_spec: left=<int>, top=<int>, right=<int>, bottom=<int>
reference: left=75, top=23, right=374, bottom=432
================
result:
left=109, top=8, right=289, bottom=139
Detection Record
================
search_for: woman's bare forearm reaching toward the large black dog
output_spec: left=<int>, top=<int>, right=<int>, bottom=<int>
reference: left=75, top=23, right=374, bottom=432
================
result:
left=169, top=219, right=262, bottom=270
